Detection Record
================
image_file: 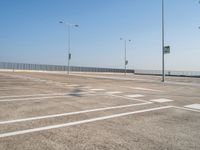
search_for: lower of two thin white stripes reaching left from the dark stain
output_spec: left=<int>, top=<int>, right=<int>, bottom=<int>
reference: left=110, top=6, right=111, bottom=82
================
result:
left=0, top=92, right=88, bottom=102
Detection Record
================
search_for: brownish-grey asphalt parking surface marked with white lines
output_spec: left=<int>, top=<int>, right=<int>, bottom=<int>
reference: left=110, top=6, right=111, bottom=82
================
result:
left=0, top=72, right=200, bottom=150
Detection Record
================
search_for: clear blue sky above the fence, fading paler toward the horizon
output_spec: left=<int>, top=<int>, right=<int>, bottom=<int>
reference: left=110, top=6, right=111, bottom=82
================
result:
left=0, top=0, right=200, bottom=71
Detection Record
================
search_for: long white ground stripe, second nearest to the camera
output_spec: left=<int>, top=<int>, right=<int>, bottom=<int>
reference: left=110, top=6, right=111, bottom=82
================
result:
left=0, top=102, right=152, bottom=125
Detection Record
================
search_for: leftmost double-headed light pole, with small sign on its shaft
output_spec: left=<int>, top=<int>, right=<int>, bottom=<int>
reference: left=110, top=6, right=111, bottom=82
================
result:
left=59, top=21, right=79, bottom=75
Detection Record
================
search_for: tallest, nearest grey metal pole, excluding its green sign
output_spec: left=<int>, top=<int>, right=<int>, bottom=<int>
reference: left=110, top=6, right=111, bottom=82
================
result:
left=162, top=0, right=165, bottom=82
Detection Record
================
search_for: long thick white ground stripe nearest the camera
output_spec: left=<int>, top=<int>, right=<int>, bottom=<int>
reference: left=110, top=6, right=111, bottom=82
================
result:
left=0, top=106, right=172, bottom=138
